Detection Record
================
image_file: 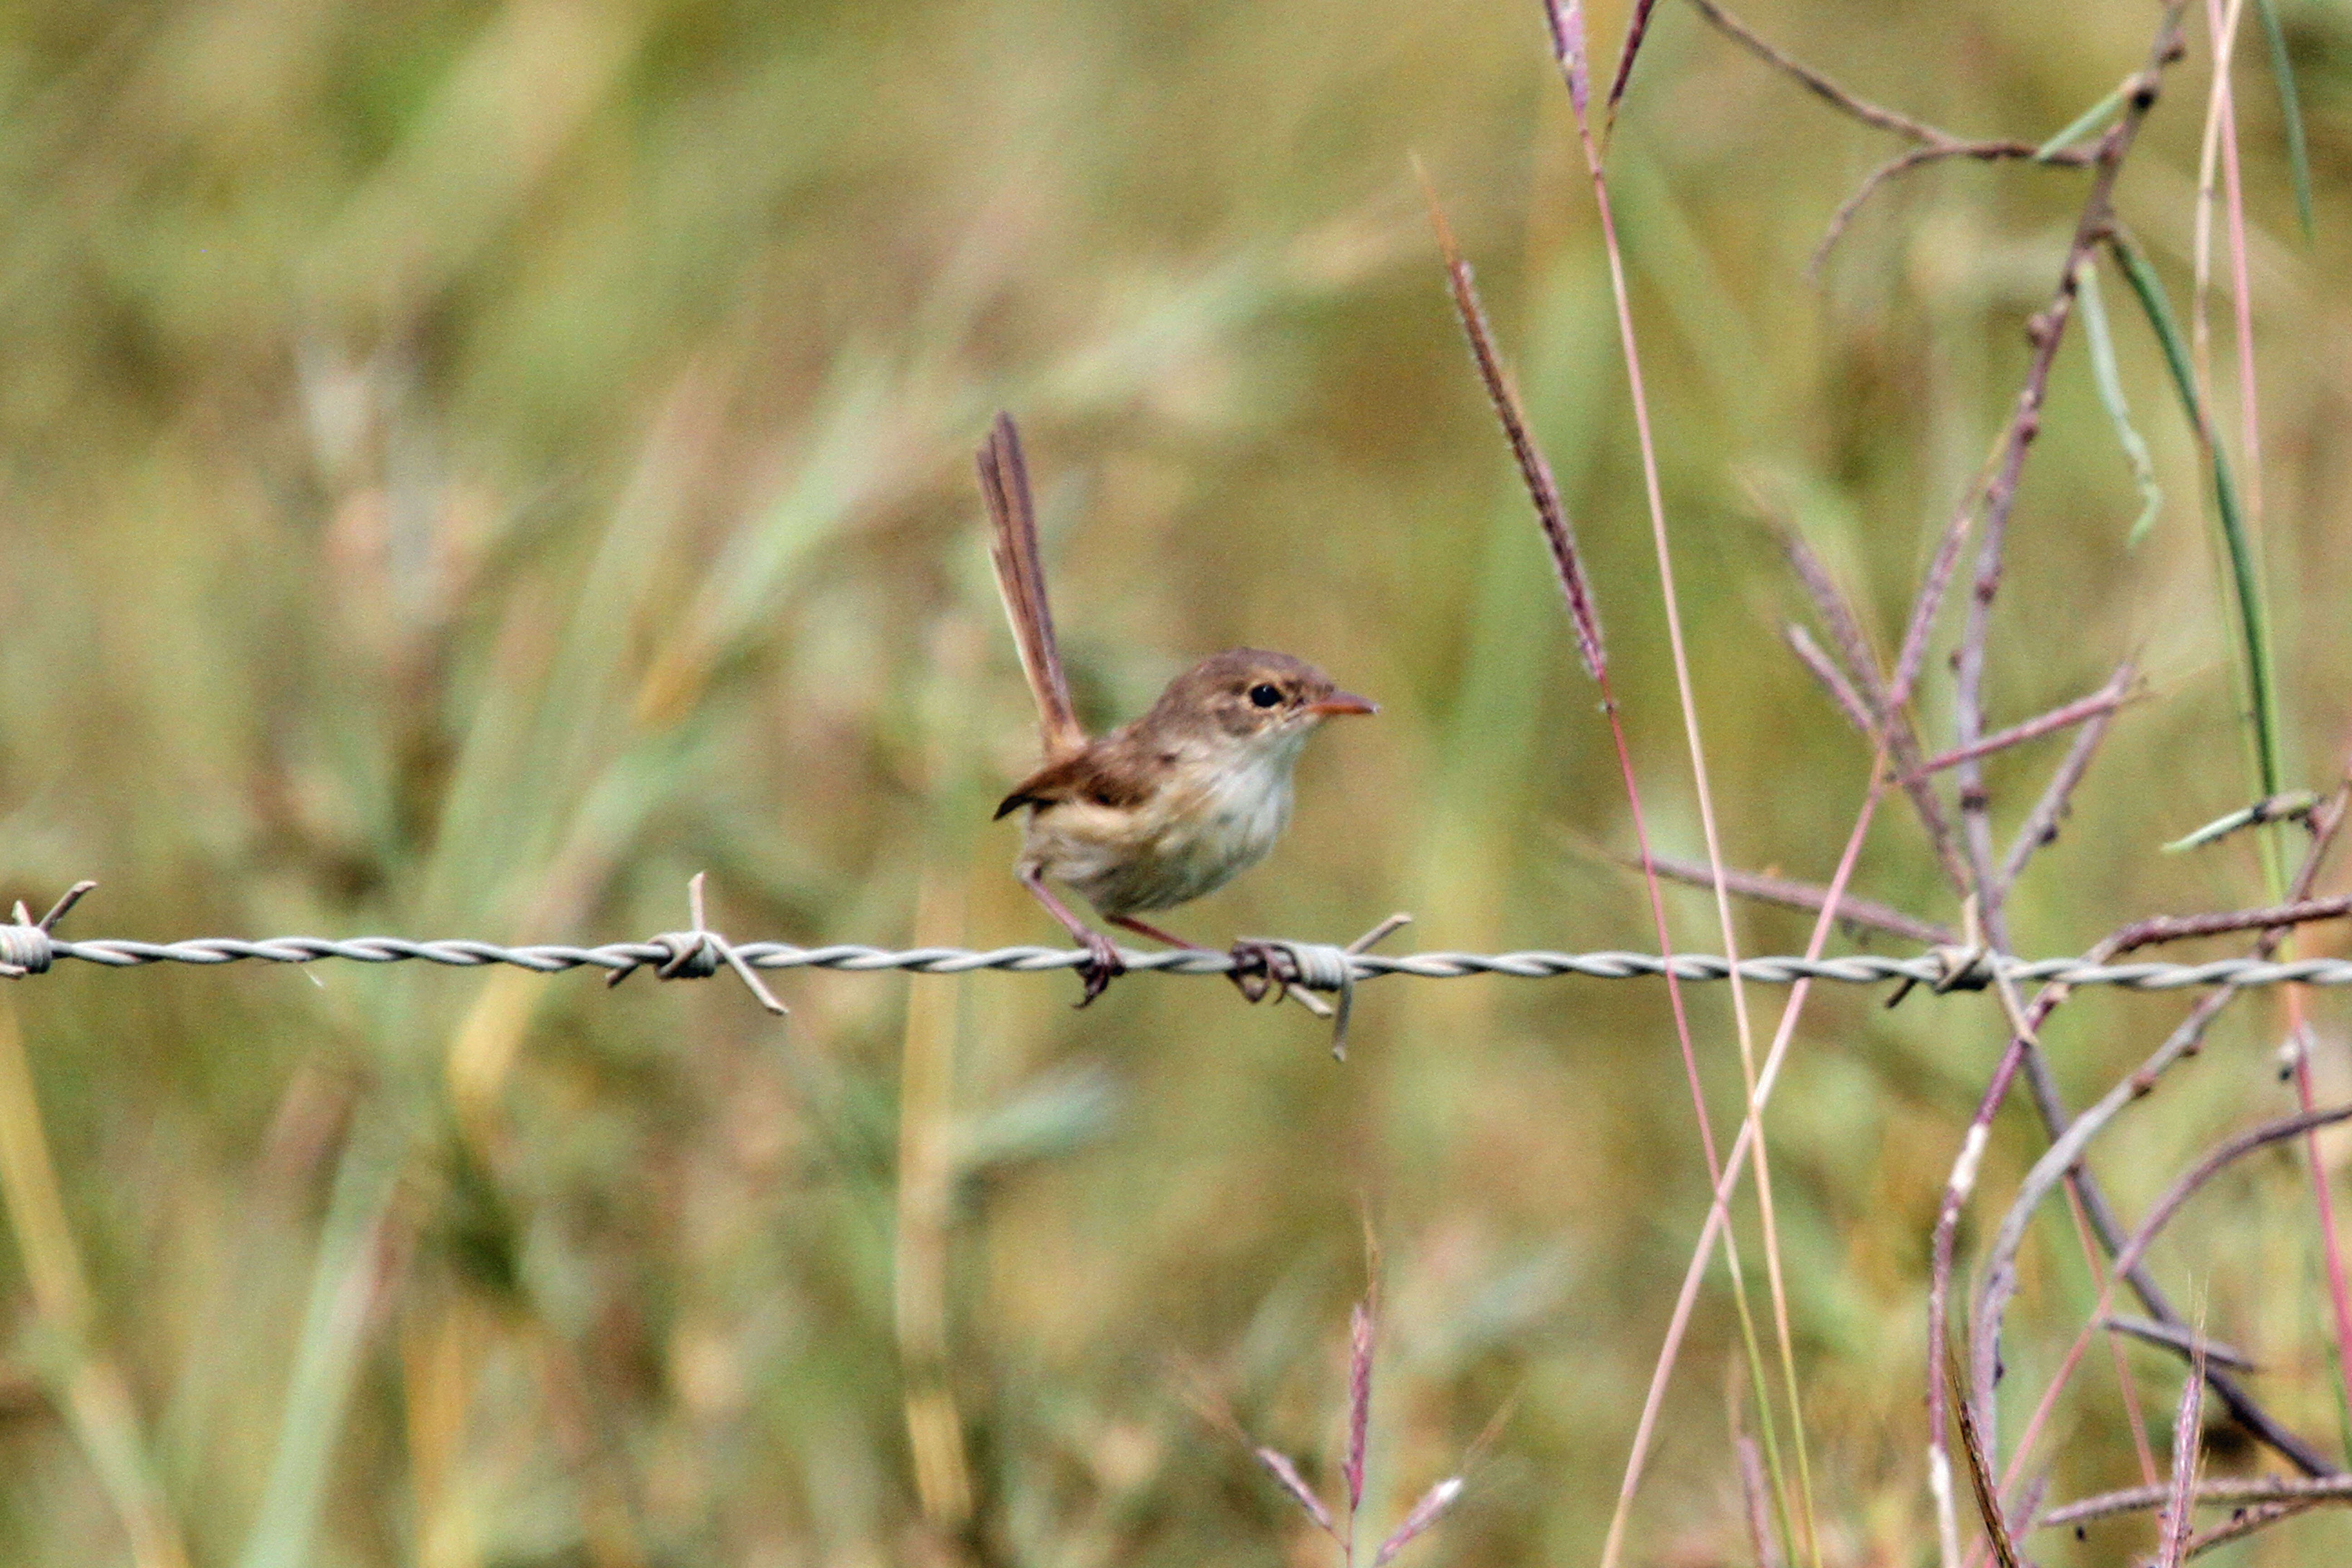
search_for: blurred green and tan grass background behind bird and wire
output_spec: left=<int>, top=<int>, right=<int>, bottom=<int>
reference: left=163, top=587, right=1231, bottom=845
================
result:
left=14, top=0, right=2352, bottom=1568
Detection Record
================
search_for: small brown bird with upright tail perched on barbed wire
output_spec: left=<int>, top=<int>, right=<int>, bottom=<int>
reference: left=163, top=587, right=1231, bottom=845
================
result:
left=981, top=414, right=1378, bottom=1006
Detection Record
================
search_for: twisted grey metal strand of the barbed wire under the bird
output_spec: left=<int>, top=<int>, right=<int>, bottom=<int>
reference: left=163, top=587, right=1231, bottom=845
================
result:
left=27, top=926, right=2352, bottom=990
